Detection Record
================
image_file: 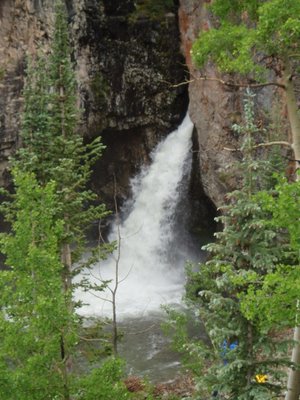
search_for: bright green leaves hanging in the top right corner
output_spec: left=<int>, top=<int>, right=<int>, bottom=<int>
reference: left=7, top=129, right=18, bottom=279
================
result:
left=192, top=0, right=300, bottom=80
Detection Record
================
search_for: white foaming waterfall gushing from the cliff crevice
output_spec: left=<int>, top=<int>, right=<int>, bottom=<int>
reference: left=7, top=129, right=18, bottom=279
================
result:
left=77, top=116, right=193, bottom=320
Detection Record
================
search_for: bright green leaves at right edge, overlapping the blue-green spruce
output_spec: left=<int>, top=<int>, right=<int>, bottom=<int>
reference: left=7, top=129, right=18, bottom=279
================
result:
left=240, top=178, right=300, bottom=329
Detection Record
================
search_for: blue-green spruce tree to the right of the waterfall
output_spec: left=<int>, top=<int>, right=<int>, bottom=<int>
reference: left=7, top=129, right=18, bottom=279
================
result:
left=180, top=93, right=288, bottom=400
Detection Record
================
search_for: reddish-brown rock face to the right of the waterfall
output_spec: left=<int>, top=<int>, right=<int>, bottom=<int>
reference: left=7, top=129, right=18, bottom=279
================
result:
left=179, top=0, right=272, bottom=207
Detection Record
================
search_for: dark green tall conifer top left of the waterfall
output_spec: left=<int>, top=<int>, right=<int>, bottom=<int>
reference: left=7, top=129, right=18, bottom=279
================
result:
left=13, top=2, right=106, bottom=261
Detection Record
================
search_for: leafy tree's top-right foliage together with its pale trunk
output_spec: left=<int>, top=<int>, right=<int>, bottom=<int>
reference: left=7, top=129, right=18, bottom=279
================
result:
left=192, top=0, right=300, bottom=400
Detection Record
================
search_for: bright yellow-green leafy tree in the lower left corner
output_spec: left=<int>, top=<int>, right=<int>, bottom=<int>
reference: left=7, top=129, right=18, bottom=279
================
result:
left=0, top=169, right=76, bottom=400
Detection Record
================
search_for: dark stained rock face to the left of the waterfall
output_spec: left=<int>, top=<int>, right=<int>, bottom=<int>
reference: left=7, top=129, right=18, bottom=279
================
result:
left=0, top=0, right=188, bottom=203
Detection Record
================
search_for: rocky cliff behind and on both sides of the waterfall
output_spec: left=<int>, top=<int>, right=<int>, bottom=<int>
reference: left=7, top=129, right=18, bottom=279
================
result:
left=0, top=0, right=270, bottom=225
